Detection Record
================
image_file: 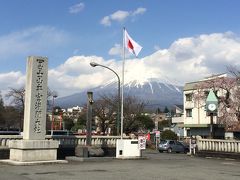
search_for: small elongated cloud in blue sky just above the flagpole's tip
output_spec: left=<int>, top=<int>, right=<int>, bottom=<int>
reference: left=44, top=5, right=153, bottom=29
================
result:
left=100, top=7, right=146, bottom=26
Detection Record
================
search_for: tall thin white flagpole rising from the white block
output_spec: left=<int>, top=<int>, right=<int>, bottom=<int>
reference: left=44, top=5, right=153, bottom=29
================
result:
left=121, top=27, right=125, bottom=139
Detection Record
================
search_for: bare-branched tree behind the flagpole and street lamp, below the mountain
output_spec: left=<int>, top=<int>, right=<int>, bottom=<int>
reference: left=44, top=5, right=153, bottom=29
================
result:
left=93, top=95, right=145, bottom=134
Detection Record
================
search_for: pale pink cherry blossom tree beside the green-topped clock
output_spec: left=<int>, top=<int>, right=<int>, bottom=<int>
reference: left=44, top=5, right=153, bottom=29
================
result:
left=193, top=77, right=240, bottom=129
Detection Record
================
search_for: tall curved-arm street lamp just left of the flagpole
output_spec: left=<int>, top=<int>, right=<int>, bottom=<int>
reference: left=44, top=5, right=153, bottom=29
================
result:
left=90, top=62, right=121, bottom=135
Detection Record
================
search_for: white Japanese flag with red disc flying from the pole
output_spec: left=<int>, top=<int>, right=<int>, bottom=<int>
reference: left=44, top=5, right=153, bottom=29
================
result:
left=124, top=30, right=142, bottom=56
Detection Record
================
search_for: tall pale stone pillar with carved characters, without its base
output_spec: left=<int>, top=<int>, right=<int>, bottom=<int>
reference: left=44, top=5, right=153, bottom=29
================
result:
left=23, top=56, right=48, bottom=140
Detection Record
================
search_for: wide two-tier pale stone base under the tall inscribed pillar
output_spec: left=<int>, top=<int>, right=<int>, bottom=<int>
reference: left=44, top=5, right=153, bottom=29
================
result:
left=2, top=140, right=67, bottom=165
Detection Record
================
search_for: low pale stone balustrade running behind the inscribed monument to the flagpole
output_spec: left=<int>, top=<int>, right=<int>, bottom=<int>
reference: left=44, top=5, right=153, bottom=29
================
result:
left=0, top=135, right=129, bottom=147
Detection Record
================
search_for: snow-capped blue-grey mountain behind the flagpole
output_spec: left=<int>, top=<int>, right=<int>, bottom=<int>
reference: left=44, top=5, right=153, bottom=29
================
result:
left=55, top=78, right=183, bottom=109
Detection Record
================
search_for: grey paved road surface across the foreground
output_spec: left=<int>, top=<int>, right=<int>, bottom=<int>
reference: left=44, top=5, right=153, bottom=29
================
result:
left=0, top=151, right=240, bottom=180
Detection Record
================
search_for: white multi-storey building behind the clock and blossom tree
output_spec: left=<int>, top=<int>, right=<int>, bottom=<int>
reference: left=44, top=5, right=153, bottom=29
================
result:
left=183, top=74, right=226, bottom=137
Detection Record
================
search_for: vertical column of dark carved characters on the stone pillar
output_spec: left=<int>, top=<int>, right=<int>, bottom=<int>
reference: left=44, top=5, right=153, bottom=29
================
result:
left=34, top=59, right=44, bottom=133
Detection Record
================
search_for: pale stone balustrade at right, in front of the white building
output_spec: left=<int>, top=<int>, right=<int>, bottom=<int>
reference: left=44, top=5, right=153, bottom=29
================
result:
left=197, top=139, right=240, bottom=153
